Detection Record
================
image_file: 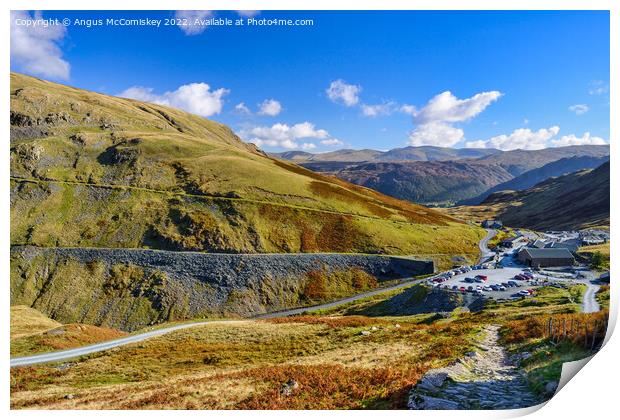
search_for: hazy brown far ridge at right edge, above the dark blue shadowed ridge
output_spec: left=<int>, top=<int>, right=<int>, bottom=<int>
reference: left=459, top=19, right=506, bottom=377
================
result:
left=475, top=145, right=609, bottom=177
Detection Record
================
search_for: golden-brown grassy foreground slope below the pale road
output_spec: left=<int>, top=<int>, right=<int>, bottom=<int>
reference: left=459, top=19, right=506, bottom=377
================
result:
left=11, top=280, right=604, bottom=408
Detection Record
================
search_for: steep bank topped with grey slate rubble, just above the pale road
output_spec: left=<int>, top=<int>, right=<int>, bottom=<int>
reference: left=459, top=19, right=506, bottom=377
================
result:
left=11, top=246, right=433, bottom=330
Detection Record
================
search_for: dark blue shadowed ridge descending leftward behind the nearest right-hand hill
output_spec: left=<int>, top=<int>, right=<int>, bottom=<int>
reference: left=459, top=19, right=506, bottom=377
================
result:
left=459, top=156, right=609, bottom=205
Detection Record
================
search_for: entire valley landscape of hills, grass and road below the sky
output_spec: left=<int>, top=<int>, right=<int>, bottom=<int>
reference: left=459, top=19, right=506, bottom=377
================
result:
left=10, top=73, right=609, bottom=409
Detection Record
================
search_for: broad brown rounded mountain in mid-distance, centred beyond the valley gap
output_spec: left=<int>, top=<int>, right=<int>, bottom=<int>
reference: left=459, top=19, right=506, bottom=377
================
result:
left=336, top=160, right=512, bottom=204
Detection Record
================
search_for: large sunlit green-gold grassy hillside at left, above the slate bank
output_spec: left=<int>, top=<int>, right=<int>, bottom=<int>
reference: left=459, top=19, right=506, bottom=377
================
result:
left=11, top=74, right=481, bottom=260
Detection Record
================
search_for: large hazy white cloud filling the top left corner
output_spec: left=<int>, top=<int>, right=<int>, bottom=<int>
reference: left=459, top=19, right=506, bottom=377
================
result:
left=11, top=11, right=71, bottom=80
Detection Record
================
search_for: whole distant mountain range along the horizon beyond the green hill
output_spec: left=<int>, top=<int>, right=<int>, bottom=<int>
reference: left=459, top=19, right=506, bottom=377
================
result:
left=272, top=145, right=609, bottom=205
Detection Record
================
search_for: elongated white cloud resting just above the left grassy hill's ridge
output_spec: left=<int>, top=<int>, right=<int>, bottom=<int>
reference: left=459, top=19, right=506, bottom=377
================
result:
left=118, top=83, right=229, bottom=117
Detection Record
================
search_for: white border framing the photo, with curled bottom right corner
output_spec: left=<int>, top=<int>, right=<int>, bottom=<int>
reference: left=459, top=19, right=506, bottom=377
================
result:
left=0, top=0, right=620, bottom=420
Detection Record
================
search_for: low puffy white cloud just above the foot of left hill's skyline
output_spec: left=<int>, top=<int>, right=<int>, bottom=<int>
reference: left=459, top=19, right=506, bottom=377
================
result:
left=239, top=121, right=338, bottom=150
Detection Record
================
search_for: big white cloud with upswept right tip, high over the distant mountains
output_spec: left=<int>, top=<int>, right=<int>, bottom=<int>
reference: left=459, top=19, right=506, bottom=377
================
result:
left=413, top=90, right=502, bottom=124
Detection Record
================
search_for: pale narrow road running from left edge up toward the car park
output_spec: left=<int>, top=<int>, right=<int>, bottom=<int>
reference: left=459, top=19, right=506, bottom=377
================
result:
left=10, top=274, right=423, bottom=367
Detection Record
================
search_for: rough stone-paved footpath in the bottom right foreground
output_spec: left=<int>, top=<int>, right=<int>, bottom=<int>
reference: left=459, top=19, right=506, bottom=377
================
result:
left=408, top=325, right=543, bottom=410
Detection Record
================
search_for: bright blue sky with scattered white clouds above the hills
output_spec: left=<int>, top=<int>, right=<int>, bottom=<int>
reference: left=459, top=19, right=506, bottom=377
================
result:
left=11, top=11, right=610, bottom=152
